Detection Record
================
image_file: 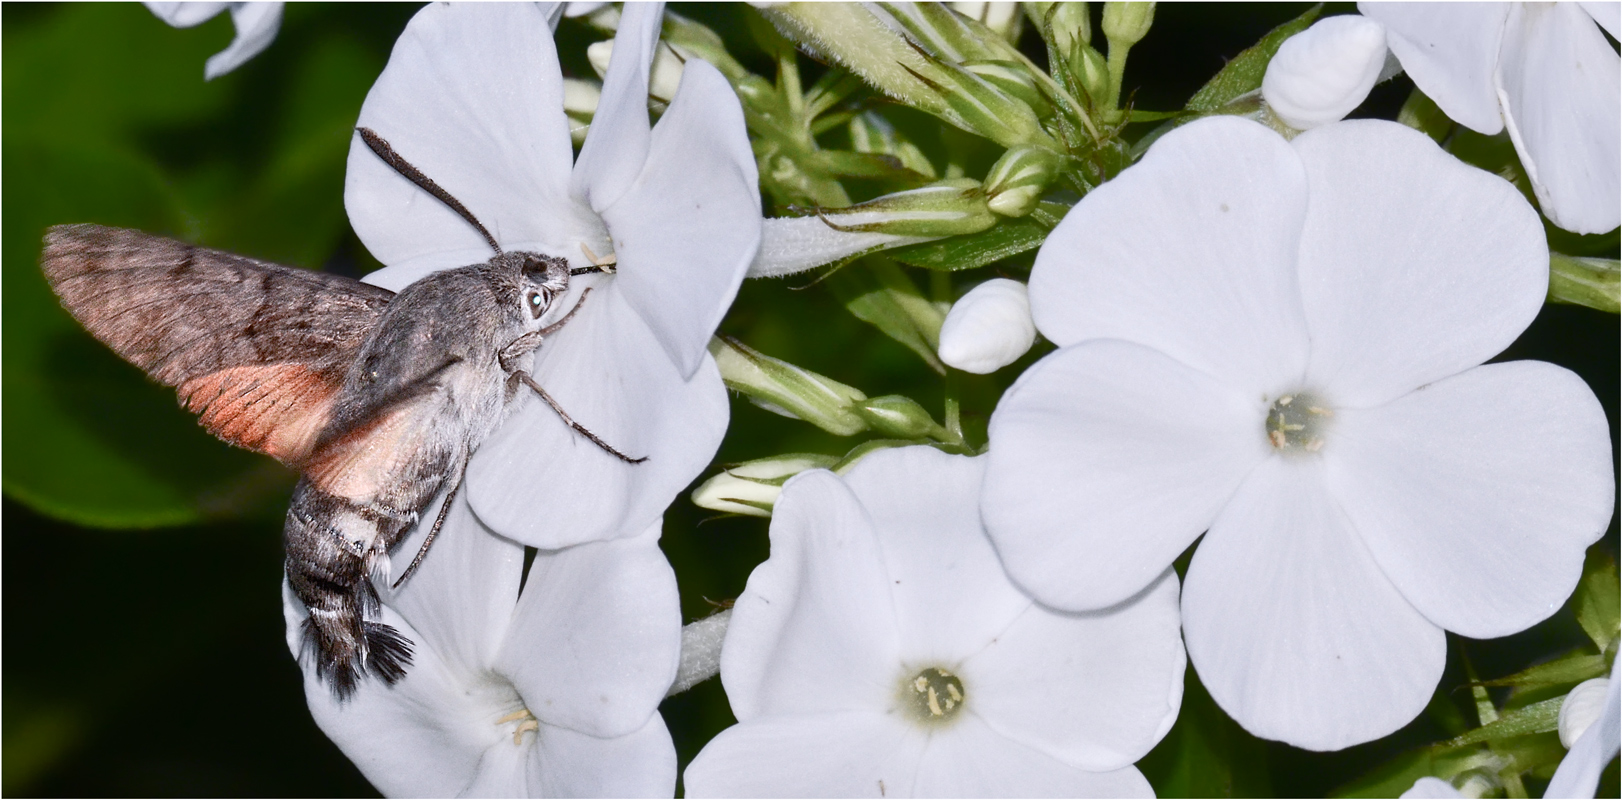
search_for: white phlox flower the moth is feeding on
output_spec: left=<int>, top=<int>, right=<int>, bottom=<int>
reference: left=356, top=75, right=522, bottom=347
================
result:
left=344, top=3, right=761, bottom=548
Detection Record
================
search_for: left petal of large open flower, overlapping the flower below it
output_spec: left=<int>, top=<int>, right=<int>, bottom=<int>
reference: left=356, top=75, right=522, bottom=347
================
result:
left=981, top=341, right=1272, bottom=610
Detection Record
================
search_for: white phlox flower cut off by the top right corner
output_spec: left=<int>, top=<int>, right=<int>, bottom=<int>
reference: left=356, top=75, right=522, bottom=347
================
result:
left=1358, top=3, right=1622, bottom=234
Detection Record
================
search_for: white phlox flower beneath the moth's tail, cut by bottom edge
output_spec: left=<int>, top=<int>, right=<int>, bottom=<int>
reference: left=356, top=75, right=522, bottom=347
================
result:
left=282, top=497, right=681, bottom=797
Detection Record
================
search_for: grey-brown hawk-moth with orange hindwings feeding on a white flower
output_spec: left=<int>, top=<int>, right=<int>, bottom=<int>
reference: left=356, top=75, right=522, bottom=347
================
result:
left=41, top=128, right=642, bottom=698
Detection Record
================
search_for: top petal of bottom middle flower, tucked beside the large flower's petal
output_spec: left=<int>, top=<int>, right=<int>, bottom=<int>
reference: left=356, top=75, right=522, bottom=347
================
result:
left=845, top=446, right=1030, bottom=669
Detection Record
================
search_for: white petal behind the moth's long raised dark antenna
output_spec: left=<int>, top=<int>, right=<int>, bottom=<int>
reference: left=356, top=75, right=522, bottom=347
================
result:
left=344, top=3, right=602, bottom=271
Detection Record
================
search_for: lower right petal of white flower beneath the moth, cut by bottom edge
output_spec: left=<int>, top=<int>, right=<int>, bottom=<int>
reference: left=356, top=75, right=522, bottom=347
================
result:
left=525, top=714, right=676, bottom=797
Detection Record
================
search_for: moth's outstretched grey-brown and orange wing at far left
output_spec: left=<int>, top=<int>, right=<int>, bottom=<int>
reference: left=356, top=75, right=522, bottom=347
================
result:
left=41, top=224, right=394, bottom=466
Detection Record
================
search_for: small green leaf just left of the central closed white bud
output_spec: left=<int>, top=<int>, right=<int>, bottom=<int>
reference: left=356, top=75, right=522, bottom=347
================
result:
left=827, top=256, right=946, bottom=375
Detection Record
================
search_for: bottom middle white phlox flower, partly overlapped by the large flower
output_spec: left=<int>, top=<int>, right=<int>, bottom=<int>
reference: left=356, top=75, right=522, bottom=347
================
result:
left=683, top=446, right=1184, bottom=797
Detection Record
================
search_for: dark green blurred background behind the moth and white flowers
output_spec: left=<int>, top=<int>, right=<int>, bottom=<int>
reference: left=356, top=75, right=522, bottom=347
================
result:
left=0, top=3, right=1619, bottom=797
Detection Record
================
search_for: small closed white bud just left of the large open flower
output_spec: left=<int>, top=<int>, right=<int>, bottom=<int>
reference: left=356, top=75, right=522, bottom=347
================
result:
left=939, top=277, right=1036, bottom=375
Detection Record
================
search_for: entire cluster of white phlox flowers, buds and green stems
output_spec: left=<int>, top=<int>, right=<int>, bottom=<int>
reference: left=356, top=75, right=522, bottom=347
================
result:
left=85, top=3, right=1622, bottom=797
